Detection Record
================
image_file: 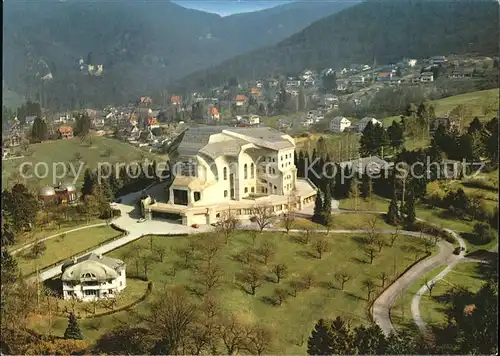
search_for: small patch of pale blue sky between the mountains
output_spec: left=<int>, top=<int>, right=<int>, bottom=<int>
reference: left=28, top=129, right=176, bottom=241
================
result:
left=173, top=0, right=290, bottom=16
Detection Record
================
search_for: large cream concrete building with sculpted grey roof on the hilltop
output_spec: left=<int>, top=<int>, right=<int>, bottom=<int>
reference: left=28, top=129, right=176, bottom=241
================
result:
left=142, top=126, right=316, bottom=225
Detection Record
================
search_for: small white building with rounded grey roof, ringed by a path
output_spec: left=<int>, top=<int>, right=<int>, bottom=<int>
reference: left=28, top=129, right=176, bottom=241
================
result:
left=61, top=253, right=127, bottom=301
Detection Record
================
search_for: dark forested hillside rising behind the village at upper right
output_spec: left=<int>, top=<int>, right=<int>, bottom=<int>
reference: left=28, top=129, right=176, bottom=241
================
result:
left=175, top=0, right=499, bottom=93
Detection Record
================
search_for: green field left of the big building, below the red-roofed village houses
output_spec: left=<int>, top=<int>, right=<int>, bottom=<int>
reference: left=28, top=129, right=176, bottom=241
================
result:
left=2, top=136, right=166, bottom=189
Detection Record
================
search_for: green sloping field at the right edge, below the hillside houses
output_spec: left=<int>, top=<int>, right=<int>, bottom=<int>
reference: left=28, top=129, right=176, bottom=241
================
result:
left=382, top=89, right=499, bottom=127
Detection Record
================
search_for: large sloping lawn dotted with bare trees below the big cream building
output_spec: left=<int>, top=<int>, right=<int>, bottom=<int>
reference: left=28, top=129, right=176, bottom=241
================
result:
left=33, top=231, right=434, bottom=354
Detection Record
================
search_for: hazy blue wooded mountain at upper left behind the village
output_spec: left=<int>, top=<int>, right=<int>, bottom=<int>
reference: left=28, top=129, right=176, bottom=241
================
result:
left=3, top=0, right=353, bottom=107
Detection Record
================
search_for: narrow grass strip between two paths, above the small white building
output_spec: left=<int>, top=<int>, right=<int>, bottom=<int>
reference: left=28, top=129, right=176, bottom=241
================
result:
left=18, top=226, right=120, bottom=275
